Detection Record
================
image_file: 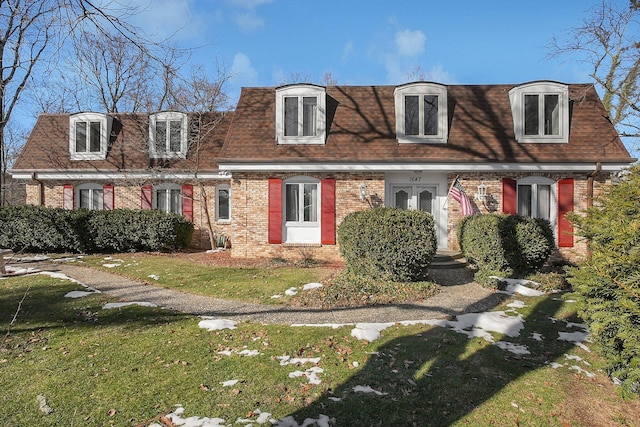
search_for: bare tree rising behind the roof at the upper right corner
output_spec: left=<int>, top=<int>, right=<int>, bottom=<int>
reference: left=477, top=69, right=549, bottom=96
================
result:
left=549, top=0, right=640, bottom=137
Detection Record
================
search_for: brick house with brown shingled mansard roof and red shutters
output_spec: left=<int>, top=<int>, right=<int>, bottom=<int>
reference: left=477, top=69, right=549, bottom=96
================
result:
left=12, top=81, right=635, bottom=259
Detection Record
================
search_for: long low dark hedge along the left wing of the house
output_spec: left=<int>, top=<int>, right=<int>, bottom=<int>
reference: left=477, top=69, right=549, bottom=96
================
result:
left=0, top=205, right=193, bottom=253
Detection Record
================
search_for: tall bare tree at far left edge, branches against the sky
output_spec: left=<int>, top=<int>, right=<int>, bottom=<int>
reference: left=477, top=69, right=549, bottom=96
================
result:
left=0, top=0, right=176, bottom=205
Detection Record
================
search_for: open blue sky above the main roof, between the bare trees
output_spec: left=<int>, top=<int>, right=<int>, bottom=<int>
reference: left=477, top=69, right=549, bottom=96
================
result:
left=126, top=0, right=628, bottom=103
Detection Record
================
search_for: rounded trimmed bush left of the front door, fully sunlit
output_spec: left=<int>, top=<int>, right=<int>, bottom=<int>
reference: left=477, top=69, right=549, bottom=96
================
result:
left=338, top=208, right=437, bottom=282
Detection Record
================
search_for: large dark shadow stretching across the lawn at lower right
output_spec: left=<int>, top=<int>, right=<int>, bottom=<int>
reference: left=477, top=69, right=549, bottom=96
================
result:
left=291, top=296, right=573, bottom=427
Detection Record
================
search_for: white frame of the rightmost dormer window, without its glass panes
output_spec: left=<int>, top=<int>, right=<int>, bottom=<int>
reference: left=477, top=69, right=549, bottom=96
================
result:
left=509, top=82, right=569, bottom=143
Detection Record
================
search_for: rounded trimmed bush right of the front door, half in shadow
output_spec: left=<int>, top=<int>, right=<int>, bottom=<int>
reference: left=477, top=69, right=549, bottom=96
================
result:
left=458, top=214, right=555, bottom=286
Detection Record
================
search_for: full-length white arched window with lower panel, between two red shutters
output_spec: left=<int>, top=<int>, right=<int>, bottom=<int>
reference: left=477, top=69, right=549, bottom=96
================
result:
left=283, top=176, right=321, bottom=243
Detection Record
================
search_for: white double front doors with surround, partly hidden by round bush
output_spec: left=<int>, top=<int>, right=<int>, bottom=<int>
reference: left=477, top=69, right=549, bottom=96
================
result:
left=385, top=172, right=448, bottom=249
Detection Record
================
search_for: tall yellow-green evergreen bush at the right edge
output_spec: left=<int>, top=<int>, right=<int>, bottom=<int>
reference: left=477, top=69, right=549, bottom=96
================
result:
left=569, top=166, right=640, bottom=394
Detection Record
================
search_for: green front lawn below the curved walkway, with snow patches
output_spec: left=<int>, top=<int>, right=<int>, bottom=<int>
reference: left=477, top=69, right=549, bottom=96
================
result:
left=0, top=266, right=640, bottom=426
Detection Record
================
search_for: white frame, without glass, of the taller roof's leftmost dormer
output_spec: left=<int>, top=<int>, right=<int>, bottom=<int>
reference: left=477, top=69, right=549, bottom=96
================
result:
left=276, top=84, right=327, bottom=144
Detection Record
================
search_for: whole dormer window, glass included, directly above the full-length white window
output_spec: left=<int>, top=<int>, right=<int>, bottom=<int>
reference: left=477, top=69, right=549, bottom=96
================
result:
left=276, top=84, right=326, bottom=144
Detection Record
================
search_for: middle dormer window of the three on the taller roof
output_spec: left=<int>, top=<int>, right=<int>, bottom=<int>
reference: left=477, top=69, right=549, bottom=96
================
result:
left=394, top=83, right=449, bottom=144
